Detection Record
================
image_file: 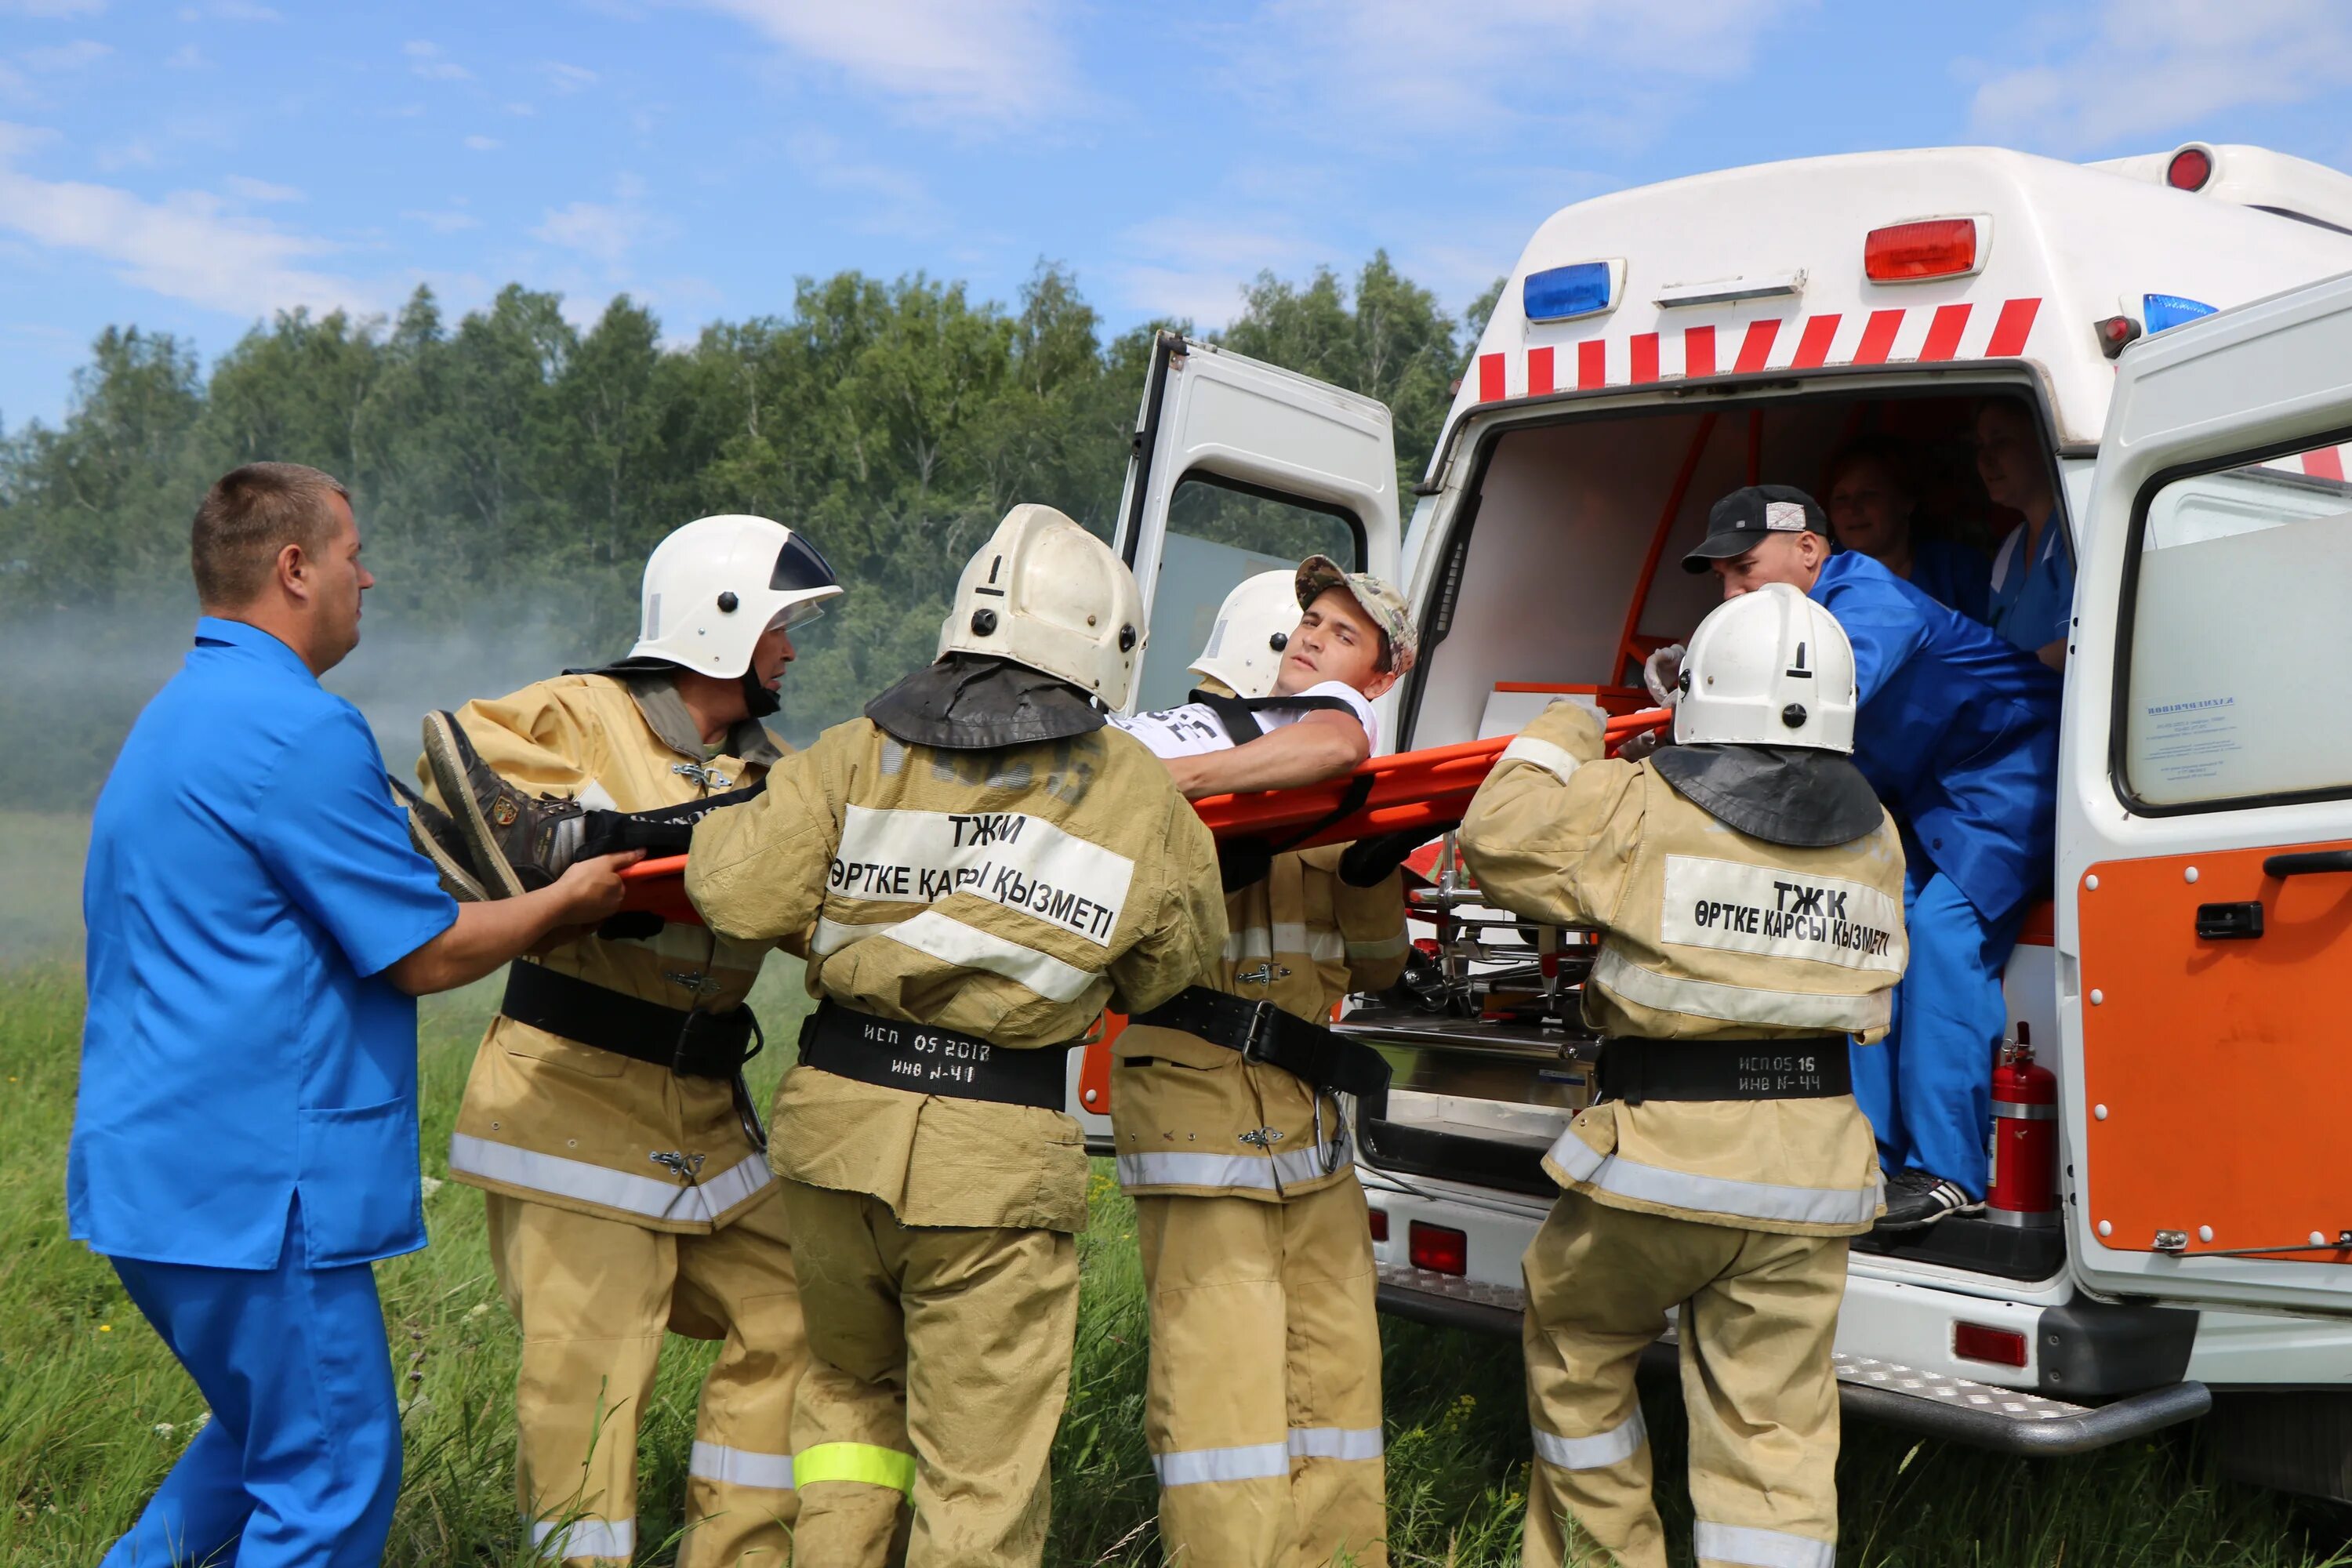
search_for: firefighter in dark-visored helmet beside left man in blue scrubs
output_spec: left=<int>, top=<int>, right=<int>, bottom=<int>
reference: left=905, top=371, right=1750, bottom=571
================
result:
left=412, top=517, right=842, bottom=1568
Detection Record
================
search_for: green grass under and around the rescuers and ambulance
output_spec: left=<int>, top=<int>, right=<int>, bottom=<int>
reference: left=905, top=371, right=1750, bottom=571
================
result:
left=0, top=959, right=2340, bottom=1568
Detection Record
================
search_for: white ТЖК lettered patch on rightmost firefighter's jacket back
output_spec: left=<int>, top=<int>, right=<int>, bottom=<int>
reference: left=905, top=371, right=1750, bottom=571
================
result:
left=1658, top=855, right=1903, bottom=975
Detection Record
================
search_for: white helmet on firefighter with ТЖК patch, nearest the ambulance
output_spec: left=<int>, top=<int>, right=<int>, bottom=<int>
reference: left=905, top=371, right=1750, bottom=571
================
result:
left=1675, top=583, right=1853, bottom=755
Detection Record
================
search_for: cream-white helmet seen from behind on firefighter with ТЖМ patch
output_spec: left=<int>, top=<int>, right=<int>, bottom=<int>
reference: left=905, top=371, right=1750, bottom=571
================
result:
left=938, top=506, right=1143, bottom=708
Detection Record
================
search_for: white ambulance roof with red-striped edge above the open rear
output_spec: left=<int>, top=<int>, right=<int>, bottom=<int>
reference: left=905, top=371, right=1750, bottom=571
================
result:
left=1439, top=148, right=2352, bottom=461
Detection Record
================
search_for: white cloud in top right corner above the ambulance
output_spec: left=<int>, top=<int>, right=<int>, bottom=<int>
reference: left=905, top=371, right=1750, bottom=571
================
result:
left=1969, top=0, right=2352, bottom=155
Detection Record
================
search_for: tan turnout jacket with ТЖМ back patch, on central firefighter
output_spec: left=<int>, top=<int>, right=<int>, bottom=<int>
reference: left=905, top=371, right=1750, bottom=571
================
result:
left=687, top=720, right=1225, bottom=1232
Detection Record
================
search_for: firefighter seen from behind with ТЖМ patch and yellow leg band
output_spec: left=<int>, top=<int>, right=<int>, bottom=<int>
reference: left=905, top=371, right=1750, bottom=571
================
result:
left=687, top=506, right=1225, bottom=1568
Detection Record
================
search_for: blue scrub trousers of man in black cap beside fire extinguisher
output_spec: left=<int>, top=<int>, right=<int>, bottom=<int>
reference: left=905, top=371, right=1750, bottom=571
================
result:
left=1853, top=853, right=2025, bottom=1199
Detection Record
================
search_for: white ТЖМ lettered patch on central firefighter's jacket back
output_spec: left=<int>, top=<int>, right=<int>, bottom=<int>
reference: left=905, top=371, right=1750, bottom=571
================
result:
left=826, top=806, right=1136, bottom=947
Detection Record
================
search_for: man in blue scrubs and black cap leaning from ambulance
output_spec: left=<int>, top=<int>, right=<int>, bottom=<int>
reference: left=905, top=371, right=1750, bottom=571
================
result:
left=1682, top=485, right=2058, bottom=1229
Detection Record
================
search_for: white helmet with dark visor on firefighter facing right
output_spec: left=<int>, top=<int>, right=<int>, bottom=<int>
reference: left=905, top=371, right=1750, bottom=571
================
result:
left=628, top=517, right=842, bottom=680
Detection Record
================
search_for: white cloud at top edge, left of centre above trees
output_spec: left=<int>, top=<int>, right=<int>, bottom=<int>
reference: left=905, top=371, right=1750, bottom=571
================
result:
left=684, top=0, right=1082, bottom=127
